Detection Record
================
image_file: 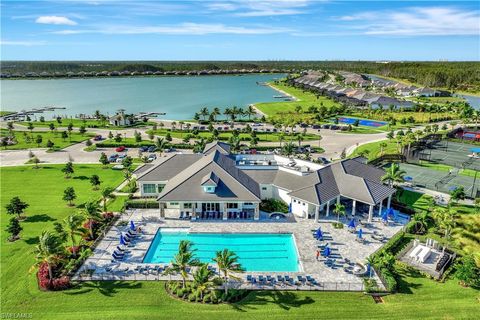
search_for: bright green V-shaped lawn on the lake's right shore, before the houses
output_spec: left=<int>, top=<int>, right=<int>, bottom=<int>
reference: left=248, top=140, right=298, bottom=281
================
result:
left=255, top=83, right=339, bottom=117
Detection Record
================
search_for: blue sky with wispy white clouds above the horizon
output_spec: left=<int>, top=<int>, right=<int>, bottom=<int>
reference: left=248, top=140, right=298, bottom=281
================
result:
left=0, top=0, right=480, bottom=60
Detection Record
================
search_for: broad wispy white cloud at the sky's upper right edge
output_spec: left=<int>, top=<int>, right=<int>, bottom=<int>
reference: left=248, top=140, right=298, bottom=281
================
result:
left=337, top=7, right=480, bottom=36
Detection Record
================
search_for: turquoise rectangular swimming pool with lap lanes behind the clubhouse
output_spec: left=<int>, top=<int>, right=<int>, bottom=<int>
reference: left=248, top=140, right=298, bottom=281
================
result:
left=143, top=229, right=300, bottom=272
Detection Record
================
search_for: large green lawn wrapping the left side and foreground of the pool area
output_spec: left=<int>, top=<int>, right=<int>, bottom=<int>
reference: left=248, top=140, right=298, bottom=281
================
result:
left=0, top=165, right=480, bottom=320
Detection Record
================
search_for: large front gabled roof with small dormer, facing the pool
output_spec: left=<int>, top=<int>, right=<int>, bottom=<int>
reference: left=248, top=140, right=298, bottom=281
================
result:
left=158, top=151, right=260, bottom=201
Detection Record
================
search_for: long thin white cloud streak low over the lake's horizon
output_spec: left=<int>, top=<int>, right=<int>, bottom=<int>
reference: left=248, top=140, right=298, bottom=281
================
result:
left=52, top=23, right=292, bottom=35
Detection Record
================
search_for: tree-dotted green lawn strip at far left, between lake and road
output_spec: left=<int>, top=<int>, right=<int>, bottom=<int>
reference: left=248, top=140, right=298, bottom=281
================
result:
left=0, top=129, right=93, bottom=150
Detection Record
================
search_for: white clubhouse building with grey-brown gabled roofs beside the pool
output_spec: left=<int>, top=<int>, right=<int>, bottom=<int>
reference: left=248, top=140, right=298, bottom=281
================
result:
left=135, top=142, right=395, bottom=221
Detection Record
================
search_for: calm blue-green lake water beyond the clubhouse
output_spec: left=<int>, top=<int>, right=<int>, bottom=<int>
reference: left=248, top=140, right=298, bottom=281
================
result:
left=0, top=74, right=285, bottom=119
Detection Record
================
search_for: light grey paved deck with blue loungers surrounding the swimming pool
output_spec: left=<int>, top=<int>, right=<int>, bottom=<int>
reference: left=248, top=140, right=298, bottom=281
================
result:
left=74, top=209, right=403, bottom=291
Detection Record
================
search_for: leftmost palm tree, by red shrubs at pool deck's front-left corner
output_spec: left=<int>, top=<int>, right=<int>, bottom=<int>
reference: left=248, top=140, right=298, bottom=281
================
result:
left=35, top=231, right=63, bottom=283
